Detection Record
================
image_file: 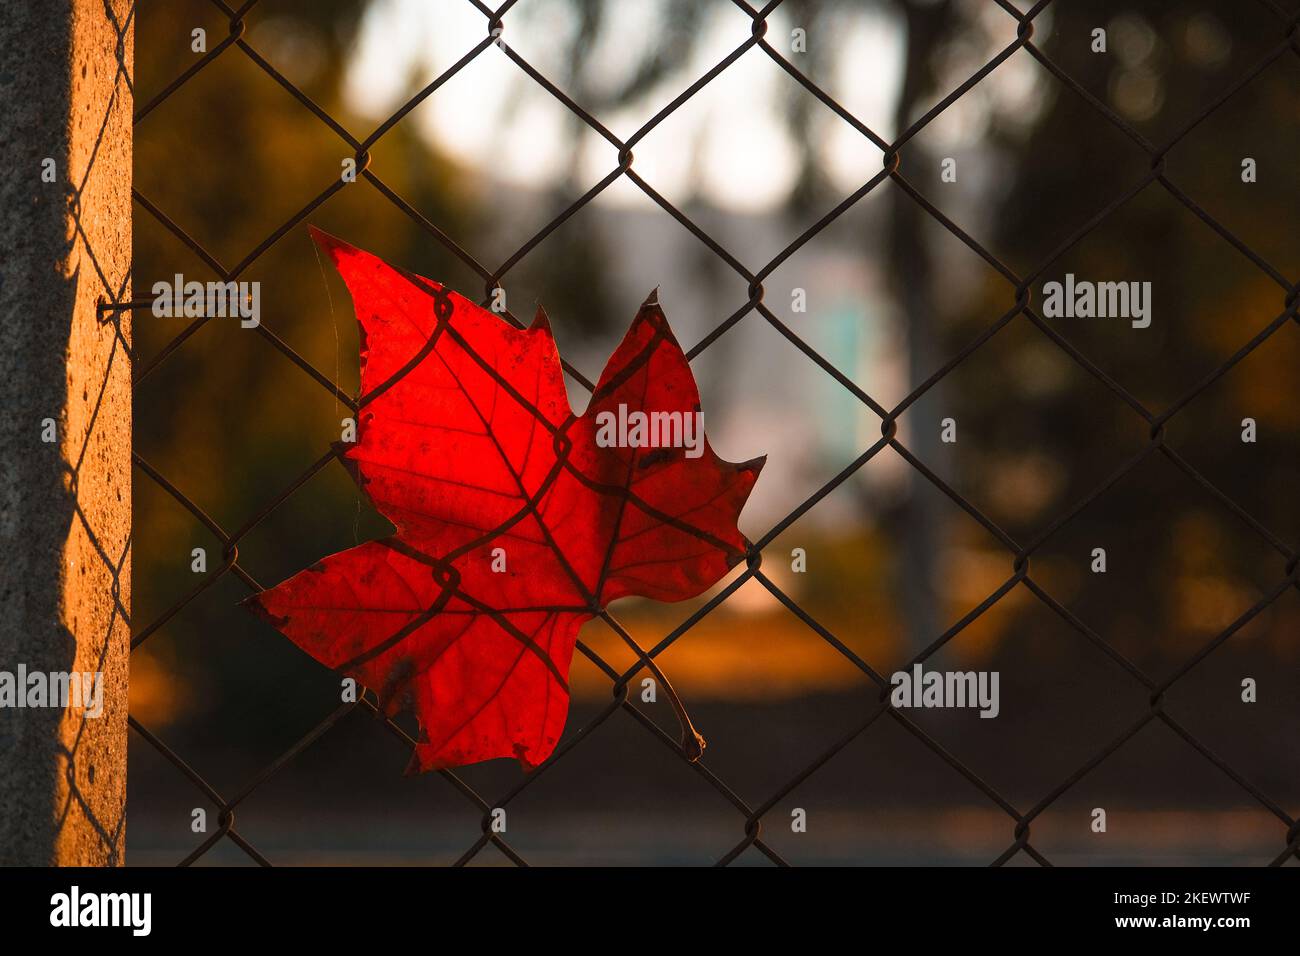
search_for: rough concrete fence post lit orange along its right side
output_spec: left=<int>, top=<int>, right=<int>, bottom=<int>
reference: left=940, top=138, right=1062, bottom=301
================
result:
left=0, top=0, right=134, bottom=865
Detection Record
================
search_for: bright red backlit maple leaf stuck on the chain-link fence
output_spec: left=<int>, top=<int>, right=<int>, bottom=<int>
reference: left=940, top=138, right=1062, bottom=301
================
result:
left=248, top=229, right=763, bottom=773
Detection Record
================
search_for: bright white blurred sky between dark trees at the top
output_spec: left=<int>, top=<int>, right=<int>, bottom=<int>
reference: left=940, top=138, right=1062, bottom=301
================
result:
left=346, top=0, right=901, bottom=211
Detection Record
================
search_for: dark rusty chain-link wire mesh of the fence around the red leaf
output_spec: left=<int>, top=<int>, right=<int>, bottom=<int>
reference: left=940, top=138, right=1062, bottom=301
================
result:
left=114, top=0, right=1300, bottom=865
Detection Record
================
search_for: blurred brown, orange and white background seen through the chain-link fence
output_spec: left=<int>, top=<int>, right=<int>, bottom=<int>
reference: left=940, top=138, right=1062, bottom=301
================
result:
left=127, top=0, right=1300, bottom=864
